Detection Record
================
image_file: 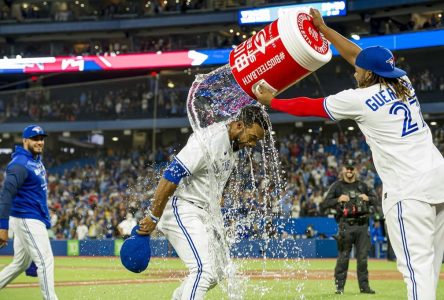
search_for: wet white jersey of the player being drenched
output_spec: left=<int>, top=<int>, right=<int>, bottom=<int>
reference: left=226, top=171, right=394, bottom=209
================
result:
left=174, top=123, right=236, bottom=207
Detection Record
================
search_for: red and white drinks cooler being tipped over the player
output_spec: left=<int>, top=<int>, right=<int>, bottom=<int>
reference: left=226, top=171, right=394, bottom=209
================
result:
left=229, top=9, right=332, bottom=98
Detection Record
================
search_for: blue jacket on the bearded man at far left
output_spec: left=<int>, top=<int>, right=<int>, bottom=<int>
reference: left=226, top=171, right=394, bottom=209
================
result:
left=0, top=146, right=51, bottom=229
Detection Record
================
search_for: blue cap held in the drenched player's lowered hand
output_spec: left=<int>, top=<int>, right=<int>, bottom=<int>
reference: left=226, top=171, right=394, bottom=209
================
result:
left=120, top=225, right=151, bottom=273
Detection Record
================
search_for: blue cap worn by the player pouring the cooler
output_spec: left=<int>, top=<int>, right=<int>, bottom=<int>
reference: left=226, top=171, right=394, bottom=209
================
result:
left=355, top=46, right=406, bottom=78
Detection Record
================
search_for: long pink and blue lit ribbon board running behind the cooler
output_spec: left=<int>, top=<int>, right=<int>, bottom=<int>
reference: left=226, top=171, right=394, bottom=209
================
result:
left=0, top=29, right=444, bottom=74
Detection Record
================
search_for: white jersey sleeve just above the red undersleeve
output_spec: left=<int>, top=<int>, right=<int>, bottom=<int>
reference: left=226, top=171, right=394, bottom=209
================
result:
left=324, top=89, right=363, bottom=120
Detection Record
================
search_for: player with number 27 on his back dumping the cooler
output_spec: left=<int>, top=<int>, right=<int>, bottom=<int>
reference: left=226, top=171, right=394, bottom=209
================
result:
left=255, top=9, right=444, bottom=300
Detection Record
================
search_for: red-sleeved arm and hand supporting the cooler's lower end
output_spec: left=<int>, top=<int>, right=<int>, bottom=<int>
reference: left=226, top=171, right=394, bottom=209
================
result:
left=254, top=85, right=330, bottom=119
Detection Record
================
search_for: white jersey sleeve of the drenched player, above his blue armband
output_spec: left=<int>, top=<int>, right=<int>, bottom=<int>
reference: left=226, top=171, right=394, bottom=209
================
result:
left=175, top=134, right=205, bottom=176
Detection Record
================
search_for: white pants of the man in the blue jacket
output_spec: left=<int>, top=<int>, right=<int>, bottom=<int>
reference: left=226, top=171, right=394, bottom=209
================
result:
left=0, top=217, right=57, bottom=300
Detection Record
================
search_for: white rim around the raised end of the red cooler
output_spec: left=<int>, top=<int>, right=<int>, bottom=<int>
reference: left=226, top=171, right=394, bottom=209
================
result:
left=278, top=10, right=332, bottom=72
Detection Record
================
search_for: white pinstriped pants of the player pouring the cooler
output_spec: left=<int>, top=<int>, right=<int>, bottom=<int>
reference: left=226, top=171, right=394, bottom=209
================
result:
left=385, top=200, right=444, bottom=300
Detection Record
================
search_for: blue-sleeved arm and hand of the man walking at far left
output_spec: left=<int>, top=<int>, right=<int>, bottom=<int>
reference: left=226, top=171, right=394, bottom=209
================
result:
left=0, top=165, right=28, bottom=248
